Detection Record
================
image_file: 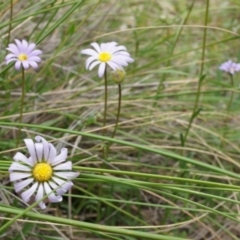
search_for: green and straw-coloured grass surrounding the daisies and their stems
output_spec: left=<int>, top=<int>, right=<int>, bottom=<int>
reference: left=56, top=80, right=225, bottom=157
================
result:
left=0, top=0, right=240, bottom=240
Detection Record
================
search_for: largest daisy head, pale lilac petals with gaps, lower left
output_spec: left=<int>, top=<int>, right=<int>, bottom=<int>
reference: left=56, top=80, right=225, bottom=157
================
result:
left=9, top=136, right=79, bottom=209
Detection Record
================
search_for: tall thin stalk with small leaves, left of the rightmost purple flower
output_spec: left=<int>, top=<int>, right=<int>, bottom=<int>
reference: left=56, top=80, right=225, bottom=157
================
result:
left=183, top=0, right=209, bottom=147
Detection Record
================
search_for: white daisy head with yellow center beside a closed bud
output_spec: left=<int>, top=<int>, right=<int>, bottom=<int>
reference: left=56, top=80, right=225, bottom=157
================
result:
left=81, top=42, right=134, bottom=78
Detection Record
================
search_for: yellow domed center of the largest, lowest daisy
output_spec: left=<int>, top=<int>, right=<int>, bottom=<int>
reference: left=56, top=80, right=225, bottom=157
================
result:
left=32, top=163, right=53, bottom=182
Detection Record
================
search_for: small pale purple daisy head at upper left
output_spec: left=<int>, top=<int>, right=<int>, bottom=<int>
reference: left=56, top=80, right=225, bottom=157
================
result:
left=5, top=39, right=42, bottom=70
